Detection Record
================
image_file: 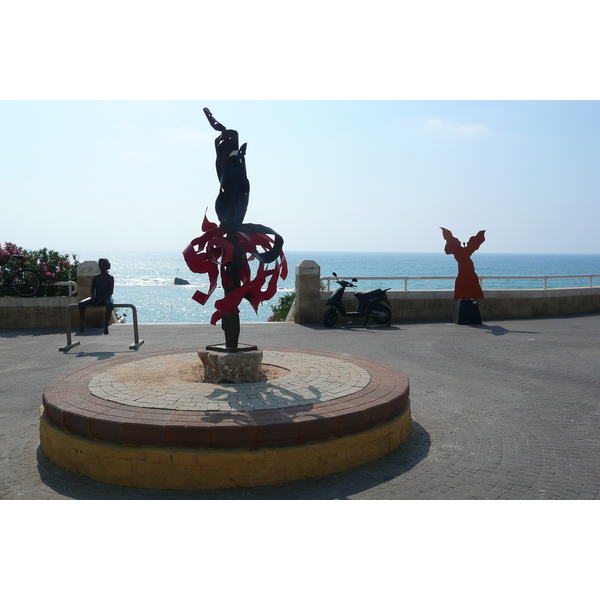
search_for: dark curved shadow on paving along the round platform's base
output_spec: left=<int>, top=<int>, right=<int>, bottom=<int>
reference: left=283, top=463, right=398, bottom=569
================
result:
left=37, top=421, right=431, bottom=500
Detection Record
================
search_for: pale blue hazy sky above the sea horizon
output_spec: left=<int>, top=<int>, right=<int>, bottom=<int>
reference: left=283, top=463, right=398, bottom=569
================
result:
left=0, top=100, right=600, bottom=254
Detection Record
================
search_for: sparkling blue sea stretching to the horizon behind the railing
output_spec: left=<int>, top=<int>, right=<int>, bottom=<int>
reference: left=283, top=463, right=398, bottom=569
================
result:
left=94, top=251, right=600, bottom=323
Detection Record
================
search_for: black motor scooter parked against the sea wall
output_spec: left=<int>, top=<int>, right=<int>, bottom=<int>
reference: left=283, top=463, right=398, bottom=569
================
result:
left=323, top=272, right=392, bottom=327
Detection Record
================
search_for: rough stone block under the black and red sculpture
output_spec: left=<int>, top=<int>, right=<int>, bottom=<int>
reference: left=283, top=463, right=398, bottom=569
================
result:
left=198, top=349, right=263, bottom=383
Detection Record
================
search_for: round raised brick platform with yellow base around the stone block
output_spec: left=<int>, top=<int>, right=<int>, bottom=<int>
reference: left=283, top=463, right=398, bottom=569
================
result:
left=40, top=348, right=412, bottom=490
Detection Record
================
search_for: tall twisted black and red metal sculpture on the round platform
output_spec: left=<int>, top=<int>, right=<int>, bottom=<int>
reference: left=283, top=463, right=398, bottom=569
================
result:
left=183, top=108, right=287, bottom=350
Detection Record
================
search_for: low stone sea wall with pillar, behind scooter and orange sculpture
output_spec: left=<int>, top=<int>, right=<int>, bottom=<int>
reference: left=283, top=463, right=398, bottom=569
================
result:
left=288, top=261, right=600, bottom=324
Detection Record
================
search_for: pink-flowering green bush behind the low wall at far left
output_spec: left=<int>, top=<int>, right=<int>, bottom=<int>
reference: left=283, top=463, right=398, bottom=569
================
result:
left=0, top=242, right=79, bottom=296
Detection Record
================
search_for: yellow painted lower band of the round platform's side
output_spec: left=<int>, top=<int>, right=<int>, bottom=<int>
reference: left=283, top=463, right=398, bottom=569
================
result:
left=40, top=404, right=412, bottom=490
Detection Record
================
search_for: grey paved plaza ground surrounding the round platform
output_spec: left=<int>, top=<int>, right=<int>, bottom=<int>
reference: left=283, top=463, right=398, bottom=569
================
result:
left=0, top=315, right=600, bottom=500
